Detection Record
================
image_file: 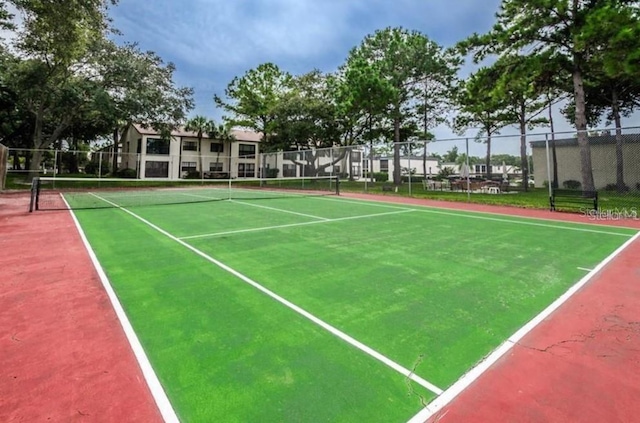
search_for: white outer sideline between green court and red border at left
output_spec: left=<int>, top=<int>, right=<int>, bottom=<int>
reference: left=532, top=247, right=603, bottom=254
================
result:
left=60, top=194, right=180, bottom=423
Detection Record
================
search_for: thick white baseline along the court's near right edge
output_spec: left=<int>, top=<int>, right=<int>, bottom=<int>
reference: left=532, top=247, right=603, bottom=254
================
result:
left=408, top=232, right=640, bottom=423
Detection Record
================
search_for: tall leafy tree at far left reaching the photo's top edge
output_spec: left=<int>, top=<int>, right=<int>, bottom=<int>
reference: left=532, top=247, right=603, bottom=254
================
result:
left=6, top=0, right=116, bottom=175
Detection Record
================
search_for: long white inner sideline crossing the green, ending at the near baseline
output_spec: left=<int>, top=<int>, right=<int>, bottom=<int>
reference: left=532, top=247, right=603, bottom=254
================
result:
left=87, top=194, right=443, bottom=395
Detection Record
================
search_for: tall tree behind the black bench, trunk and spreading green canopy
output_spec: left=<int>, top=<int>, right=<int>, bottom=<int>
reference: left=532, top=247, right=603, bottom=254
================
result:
left=462, top=0, right=637, bottom=190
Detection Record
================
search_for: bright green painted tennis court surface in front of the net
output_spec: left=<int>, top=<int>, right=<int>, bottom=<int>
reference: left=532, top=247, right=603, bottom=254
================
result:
left=71, top=194, right=635, bottom=422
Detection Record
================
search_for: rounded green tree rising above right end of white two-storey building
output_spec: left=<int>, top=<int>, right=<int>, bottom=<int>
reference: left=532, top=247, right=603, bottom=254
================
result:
left=213, top=63, right=292, bottom=142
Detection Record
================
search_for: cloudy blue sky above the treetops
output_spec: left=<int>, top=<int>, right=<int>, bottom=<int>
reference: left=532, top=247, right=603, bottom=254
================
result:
left=111, top=0, right=500, bottom=118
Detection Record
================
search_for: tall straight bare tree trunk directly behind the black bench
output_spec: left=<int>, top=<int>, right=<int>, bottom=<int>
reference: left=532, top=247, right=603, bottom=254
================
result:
left=573, top=66, right=595, bottom=191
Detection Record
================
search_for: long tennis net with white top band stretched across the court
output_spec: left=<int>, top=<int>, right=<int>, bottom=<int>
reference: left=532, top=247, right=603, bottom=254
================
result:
left=29, top=176, right=339, bottom=211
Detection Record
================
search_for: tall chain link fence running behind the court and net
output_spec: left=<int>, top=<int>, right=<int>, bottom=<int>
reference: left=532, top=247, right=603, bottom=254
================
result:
left=5, top=128, right=640, bottom=210
